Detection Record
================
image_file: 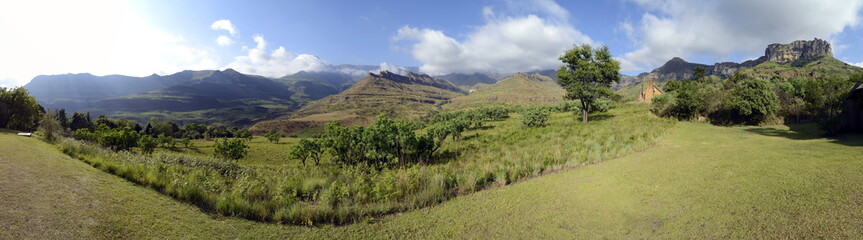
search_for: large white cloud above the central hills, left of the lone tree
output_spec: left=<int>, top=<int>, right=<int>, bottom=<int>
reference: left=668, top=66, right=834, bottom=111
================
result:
left=392, top=0, right=593, bottom=75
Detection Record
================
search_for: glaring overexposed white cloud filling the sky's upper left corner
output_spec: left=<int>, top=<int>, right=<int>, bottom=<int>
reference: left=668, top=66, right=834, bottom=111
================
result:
left=0, top=0, right=219, bottom=86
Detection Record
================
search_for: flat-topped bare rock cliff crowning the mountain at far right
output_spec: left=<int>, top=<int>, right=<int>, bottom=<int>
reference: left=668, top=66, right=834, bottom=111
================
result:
left=764, top=38, right=833, bottom=63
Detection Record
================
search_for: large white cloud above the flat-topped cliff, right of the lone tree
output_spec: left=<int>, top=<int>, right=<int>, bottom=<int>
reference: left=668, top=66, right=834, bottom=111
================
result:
left=622, top=0, right=863, bottom=71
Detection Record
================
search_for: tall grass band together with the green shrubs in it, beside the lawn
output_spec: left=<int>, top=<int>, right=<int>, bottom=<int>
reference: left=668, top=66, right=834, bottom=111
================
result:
left=54, top=105, right=672, bottom=224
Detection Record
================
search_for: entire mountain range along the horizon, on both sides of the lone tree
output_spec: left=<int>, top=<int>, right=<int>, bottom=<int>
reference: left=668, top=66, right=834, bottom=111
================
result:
left=24, top=38, right=863, bottom=126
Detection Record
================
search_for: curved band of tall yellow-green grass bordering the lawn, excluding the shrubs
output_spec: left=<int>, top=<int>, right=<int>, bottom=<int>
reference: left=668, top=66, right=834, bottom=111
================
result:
left=58, top=105, right=673, bottom=225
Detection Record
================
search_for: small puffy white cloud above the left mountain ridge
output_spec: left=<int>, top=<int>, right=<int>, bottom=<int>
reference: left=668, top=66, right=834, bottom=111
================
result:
left=227, top=35, right=328, bottom=77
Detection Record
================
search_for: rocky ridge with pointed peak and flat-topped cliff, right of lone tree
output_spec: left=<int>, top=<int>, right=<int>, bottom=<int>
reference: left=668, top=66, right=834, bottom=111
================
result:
left=636, top=38, right=833, bottom=82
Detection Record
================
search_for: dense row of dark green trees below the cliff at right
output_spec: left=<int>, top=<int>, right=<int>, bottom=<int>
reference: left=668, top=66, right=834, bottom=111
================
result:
left=653, top=70, right=863, bottom=129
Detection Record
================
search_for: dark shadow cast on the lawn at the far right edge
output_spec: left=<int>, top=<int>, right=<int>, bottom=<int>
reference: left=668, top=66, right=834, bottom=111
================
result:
left=745, top=123, right=863, bottom=146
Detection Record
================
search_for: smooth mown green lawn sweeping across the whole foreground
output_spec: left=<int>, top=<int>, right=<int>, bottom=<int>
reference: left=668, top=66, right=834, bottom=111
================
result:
left=0, top=119, right=863, bottom=239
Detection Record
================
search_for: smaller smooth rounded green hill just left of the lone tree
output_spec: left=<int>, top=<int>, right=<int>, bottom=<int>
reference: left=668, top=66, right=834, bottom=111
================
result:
left=443, top=73, right=565, bottom=109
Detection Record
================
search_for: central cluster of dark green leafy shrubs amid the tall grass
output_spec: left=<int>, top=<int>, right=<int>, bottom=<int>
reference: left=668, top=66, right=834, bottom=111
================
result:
left=289, top=107, right=510, bottom=168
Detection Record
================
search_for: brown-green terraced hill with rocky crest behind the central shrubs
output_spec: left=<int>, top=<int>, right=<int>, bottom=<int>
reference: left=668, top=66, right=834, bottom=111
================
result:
left=294, top=71, right=465, bottom=119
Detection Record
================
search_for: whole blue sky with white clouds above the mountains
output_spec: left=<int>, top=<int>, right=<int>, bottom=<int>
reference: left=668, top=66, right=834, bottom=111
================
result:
left=0, top=0, right=863, bottom=87
